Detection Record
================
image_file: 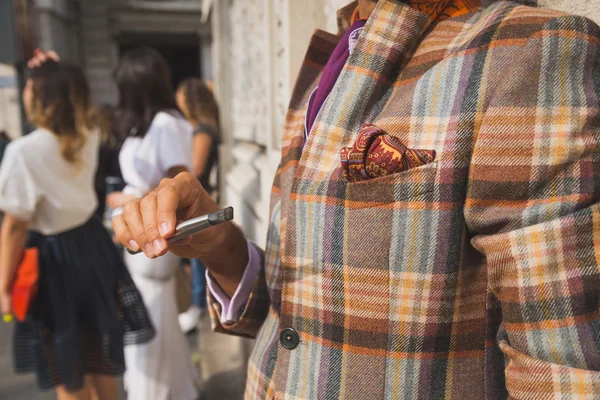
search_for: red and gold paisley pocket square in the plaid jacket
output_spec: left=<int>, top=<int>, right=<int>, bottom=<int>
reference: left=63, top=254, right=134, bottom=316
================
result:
left=341, top=124, right=435, bottom=182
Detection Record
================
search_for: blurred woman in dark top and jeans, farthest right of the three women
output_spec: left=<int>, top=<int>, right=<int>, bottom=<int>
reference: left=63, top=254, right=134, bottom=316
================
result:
left=176, top=78, right=220, bottom=333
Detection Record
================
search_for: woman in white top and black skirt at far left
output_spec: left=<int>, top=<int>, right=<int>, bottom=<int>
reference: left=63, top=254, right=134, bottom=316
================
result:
left=0, top=60, right=154, bottom=399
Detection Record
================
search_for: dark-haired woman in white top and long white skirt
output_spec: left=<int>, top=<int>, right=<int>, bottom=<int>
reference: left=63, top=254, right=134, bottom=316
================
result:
left=107, top=48, right=198, bottom=400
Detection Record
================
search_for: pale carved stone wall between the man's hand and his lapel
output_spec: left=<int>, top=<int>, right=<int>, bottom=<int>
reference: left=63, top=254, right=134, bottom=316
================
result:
left=212, top=0, right=327, bottom=245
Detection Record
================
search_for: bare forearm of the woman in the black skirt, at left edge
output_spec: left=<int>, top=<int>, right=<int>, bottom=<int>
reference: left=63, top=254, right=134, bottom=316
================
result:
left=0, top=215, right=27, bottom=292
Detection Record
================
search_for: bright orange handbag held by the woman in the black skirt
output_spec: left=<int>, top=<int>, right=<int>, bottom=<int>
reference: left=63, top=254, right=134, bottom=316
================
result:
left=12, top=247, right=40, bottom=322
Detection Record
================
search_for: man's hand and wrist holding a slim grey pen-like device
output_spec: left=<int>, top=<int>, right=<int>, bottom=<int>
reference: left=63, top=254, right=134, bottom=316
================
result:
left=112, top=172, right=248, bottom=296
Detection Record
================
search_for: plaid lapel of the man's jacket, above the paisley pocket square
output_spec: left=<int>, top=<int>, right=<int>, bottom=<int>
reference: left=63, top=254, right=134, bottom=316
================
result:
left=296, top=0, right=431, bottom=184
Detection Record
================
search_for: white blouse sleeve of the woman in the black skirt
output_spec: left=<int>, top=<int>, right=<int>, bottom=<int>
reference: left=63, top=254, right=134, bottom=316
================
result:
left=0, top=143, right=40, bottom=222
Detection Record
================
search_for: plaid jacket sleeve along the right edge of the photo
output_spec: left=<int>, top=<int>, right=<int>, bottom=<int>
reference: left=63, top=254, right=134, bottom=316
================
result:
left=465, top=16, right=600, bottom=399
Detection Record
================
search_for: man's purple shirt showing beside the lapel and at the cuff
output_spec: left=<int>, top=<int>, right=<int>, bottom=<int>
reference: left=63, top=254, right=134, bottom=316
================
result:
left=206, top=20, right=365, bottom=324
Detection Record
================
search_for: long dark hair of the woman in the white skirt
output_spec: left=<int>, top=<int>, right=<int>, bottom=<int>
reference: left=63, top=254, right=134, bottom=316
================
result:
left=114, top=47, right=177, bottom=137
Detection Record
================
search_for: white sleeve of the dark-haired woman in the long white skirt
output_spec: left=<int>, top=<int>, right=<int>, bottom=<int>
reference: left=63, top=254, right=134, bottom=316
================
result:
left=157, top=121, right=193, bottom=173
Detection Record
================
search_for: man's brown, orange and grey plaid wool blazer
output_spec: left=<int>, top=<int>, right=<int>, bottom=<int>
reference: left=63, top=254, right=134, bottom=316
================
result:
left=211, top=0, right=600, bottom=400
